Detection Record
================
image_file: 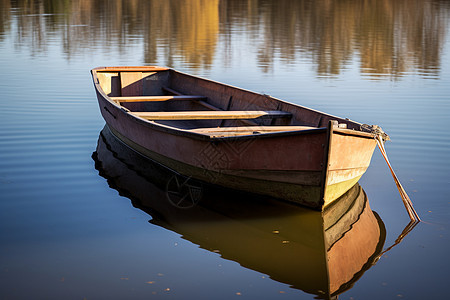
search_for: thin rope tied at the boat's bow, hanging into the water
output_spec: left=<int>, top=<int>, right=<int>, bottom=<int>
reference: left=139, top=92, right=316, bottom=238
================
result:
left=361, top=124, right=421, bottom=222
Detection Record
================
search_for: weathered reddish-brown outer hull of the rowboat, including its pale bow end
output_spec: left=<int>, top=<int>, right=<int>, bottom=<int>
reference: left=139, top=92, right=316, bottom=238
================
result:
left=93, top=67, right=376, bottom=210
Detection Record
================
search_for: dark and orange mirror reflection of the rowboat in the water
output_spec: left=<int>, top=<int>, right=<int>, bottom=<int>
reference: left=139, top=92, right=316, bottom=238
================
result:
left=93, top=126, right=386, bottom=298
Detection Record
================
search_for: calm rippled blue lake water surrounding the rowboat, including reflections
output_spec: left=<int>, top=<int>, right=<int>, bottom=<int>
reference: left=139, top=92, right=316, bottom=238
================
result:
left=0, top=0, right=450, bottom=299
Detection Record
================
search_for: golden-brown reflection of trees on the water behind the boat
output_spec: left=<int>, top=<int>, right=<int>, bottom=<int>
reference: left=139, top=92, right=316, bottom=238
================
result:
left=0, top=0, right=450, bottom=77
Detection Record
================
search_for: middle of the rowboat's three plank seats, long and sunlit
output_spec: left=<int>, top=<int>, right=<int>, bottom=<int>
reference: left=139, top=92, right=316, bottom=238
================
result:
left=131, top=110, right=292, bottom=120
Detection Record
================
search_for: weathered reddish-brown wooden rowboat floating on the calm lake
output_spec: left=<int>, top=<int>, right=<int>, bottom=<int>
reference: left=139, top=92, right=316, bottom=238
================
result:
left=91, top=66, right=388, bottom=210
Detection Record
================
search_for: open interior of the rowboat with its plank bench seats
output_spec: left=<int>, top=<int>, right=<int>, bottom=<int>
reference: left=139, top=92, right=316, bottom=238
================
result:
left=94, top=67, right=360, bottom=137
